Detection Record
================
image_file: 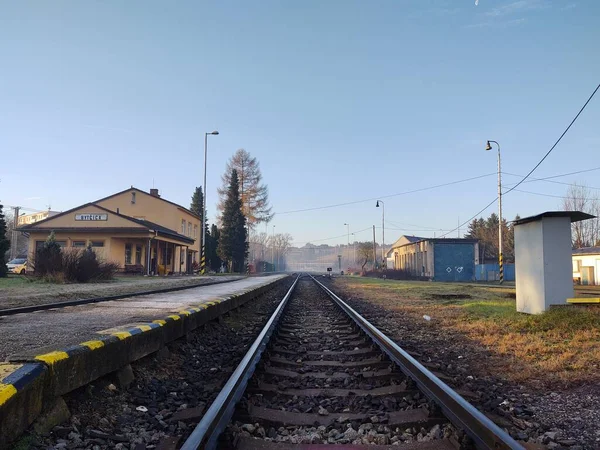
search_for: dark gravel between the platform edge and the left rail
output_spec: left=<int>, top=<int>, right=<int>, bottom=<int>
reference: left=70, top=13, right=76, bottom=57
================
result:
left=22, top=280, right=292, bottom=450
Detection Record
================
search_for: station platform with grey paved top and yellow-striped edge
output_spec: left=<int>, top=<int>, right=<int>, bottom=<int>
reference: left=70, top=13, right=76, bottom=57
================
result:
left=0, top=274, right=287, bottom=448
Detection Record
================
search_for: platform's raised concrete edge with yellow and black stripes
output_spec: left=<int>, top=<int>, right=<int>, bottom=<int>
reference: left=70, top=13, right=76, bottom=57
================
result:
left=0, top=277, right=286, bottom=448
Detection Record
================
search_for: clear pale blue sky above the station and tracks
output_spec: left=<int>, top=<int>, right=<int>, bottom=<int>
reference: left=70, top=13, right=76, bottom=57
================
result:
left=0, top=0, right=600, bottom=245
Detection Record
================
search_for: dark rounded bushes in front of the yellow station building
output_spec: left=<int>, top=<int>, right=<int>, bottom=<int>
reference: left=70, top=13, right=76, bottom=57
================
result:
left=34, top=237, right=119, bottom=283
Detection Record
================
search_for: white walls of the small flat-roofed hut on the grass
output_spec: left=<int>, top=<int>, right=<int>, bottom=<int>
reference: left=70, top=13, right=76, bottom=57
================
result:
left=515, top=217, right=573, bottom=314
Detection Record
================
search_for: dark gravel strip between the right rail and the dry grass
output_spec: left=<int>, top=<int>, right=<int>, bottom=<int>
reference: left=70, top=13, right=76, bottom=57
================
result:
left=331, top=281, right=600, bottom=450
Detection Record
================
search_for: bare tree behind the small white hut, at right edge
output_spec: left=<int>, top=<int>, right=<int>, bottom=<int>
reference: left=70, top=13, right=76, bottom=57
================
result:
left=562, top=184, right=600, bottom=248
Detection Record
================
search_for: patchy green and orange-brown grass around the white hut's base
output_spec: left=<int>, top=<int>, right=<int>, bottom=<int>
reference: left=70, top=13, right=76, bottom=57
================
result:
left=336, top=278, right=600, bottom=385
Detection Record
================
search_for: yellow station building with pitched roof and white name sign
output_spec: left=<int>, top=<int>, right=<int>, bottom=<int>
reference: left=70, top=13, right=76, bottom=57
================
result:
left=19, top=187, right=201, bottom=275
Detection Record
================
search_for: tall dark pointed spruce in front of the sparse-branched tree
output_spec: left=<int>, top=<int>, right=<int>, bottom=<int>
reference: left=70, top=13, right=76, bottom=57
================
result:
left=218, top=169, right=248, bottom=272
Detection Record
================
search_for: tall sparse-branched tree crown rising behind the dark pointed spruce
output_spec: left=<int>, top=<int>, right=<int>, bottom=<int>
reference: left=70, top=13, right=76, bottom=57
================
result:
left=217, top=148, right=273, bottom=228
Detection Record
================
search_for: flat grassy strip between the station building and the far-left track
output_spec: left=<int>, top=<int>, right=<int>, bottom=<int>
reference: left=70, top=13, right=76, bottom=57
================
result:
left=0, top=275, right=245, bottom=310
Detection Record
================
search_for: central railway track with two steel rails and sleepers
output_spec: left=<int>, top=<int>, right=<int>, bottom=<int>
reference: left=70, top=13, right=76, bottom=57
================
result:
left=181, top=276, right=523, bottom=450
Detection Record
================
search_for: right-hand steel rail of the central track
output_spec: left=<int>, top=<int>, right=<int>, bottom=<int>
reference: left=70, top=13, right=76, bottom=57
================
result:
left=311, top=276, right=524, bottom=450
